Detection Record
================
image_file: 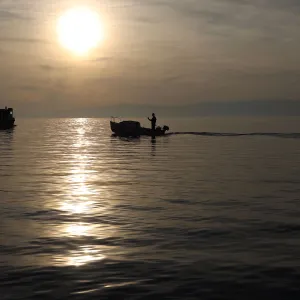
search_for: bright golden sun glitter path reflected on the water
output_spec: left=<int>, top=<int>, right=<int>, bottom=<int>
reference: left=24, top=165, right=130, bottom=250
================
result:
left=54, top=119, right=109, bottom=266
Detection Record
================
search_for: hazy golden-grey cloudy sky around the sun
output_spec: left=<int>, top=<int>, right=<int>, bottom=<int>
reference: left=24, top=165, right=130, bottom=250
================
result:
left=0, top=0, right=300, bottom=116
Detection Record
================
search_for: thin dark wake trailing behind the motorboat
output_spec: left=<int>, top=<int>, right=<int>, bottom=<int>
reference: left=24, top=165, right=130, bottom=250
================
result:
left=167, top=131, right=300, bottom=139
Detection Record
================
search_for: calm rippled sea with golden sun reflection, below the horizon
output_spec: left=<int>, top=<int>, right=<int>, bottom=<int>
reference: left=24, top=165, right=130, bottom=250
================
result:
left=0, top=118, right=300, bottom=300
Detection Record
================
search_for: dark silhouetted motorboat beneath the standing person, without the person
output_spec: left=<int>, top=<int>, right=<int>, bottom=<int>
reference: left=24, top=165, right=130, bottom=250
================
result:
left=110, top=117, right=169, bottom=137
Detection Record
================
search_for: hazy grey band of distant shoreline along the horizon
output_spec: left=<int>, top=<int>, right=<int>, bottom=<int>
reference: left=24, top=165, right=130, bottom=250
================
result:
left=6, top=100, right=300, bottom=118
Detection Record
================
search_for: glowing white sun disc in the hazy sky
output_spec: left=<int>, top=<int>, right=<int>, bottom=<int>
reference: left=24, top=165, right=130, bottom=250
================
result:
left=57, top=7, right=104, bottom=55
